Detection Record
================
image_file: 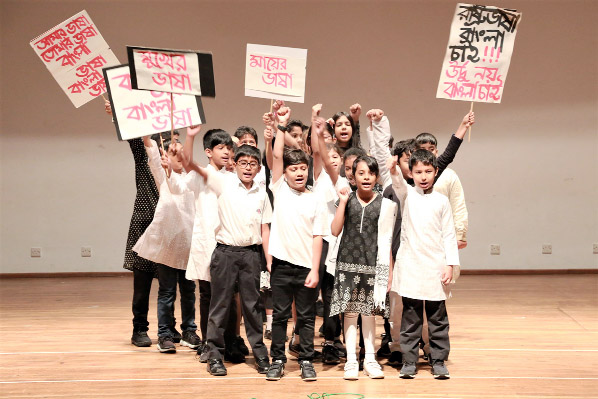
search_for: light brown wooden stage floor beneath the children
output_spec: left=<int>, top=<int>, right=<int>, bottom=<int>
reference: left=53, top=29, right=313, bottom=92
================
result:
left=0, top=274, right=598, bottom=399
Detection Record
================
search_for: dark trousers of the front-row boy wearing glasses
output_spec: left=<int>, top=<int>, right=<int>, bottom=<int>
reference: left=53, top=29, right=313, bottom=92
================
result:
left=207, top=244, right=268, bottom=359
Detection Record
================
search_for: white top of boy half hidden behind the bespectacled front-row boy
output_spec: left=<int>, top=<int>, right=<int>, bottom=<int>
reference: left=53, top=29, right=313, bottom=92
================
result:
left=185, top=165, right=228, bottom=281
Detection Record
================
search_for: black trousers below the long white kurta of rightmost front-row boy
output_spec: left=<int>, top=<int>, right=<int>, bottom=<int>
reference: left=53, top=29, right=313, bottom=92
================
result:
left=400, top=297, right=451, bottom=363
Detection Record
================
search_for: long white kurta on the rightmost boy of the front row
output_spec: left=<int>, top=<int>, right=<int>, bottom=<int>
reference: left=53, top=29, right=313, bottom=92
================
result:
left=391, top=171, right=459, bottom=301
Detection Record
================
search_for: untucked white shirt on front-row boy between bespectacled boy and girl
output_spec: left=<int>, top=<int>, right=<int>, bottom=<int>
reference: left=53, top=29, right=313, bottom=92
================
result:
left=268, top=176, right=330, bottom=269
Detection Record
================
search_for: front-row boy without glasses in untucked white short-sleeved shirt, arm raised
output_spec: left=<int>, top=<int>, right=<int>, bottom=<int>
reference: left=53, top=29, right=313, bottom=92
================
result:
left=264, top=102, right=329, bottom=381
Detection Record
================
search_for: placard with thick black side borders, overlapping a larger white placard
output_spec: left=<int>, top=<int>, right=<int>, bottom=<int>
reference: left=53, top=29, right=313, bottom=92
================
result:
left=127, top=46, right=216, bottom=97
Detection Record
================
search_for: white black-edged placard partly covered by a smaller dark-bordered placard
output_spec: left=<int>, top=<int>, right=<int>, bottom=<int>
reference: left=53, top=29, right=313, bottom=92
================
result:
left=104, top=64, right=206, bottom=140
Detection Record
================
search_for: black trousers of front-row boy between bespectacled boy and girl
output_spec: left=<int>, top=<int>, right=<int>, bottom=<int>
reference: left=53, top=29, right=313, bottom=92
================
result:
left=270, top=258, right=318, bottom=363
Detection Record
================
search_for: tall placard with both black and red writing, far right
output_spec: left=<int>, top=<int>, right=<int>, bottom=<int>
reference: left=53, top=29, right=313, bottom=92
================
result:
left=436, top=3, right=521, bottom=103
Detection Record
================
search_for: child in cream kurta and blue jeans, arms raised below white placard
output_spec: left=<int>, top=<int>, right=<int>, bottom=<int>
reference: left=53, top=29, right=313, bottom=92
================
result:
left=133, top=128, right=200, bottom=353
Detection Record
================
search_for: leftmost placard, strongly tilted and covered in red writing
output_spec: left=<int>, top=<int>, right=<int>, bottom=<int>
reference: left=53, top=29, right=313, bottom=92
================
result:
left=29, top=10, right=119, bottom=108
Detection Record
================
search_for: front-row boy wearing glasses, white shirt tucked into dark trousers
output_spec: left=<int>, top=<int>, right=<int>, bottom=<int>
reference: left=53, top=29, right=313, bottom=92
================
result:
left=189, top=144, right=272, bottom=376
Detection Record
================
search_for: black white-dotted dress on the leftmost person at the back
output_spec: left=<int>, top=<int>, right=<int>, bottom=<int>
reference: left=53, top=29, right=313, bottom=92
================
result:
left=123, top=138, right=159, bottom=273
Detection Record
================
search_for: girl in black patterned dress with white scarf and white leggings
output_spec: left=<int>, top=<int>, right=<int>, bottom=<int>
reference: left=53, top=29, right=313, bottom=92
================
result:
left=330, top=152, right=397, bottom=380
